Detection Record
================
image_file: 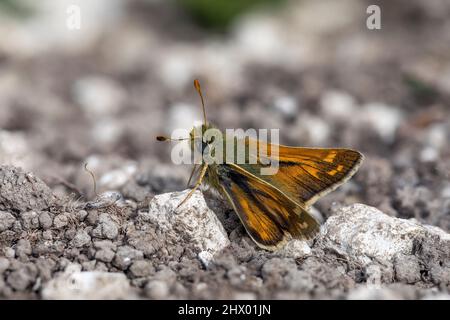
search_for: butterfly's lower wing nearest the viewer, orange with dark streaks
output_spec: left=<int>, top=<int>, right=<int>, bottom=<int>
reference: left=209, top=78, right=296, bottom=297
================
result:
left=218, top=164, right=319, bottom=250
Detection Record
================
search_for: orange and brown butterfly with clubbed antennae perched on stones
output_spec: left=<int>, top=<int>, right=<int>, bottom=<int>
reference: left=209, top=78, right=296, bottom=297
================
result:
left=157, top=80, right=364, bottom=251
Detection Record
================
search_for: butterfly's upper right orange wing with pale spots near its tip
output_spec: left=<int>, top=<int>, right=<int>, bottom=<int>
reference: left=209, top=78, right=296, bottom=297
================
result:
left=238, top=140, right=364, bottom=207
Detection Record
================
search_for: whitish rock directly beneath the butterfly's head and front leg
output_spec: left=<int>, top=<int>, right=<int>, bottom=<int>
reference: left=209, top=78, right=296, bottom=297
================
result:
left=143, top=190, right=230, bottom=263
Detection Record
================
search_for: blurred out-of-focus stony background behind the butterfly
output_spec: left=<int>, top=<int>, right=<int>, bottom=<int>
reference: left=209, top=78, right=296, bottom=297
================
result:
left=0, top=0, right=450, bottom=231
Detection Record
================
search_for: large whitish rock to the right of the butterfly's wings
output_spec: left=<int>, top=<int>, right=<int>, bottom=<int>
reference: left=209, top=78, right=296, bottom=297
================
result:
left=319, top=204, right=450, bottom=265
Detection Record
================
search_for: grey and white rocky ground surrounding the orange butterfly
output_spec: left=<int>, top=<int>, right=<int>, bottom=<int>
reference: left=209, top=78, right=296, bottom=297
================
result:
left=0, top=0, right=450, bottom=299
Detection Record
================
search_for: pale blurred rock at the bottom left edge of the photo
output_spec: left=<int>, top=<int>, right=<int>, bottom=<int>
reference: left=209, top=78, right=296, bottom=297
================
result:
left=42, top=270, right=136, bottom=300
